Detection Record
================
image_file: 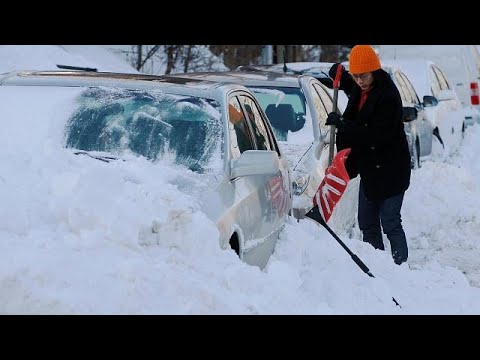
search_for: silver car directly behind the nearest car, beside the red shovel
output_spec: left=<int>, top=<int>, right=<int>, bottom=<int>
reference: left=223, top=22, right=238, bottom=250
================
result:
left=164, top=68, right=344, bottom=218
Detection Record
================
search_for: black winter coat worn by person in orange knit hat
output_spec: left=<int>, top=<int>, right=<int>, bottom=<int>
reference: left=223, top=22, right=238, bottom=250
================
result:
left=337, top=69, right=411, bottom=200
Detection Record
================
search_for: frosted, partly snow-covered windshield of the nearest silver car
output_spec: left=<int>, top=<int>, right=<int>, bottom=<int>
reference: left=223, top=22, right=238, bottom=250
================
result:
left=0, top=86, right=223, bottom=173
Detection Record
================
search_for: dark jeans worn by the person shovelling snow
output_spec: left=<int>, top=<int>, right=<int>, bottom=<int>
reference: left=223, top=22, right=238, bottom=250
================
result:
left=358, top=181, right=408, bottom=265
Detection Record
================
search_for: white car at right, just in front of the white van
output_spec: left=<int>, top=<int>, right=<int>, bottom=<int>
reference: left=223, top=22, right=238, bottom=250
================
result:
left=382, top=58, right=466, bottom=153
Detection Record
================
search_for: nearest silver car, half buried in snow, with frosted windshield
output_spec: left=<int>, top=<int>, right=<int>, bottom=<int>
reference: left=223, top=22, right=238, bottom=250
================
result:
left=0, top=71, right=292, bottom=268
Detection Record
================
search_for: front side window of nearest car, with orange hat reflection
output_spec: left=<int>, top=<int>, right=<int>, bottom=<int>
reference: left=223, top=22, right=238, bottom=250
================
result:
left=228, top=97, right=255, bottom=160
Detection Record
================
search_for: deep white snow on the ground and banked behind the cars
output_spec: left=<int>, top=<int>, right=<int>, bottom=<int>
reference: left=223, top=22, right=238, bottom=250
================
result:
left=0, top=46, right=480, bottom=315
